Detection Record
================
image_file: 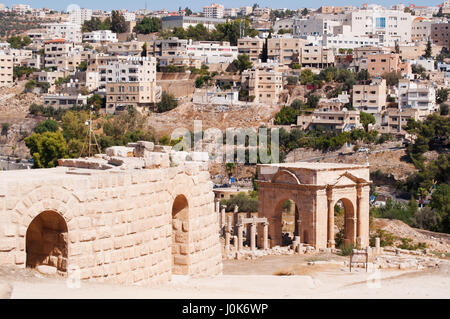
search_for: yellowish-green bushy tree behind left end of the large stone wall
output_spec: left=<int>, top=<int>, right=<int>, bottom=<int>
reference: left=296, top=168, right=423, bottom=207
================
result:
left=25, top=132, right=68, bottom=168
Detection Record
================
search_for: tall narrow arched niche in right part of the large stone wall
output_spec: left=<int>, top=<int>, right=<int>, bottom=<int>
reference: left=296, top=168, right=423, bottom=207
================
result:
left=172, top=195, right=189, bottom=275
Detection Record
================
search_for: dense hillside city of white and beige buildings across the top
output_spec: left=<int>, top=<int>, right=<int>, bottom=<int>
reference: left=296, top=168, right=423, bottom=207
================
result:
left=0, top=1, right=450, bottom=134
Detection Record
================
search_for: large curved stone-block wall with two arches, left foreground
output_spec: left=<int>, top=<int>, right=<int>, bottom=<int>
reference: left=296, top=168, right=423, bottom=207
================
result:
left=0, top=142, right=222, bottom=284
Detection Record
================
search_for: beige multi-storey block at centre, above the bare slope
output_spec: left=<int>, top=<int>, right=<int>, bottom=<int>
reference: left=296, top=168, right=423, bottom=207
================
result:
left=241, top=63, right=283, bottom=104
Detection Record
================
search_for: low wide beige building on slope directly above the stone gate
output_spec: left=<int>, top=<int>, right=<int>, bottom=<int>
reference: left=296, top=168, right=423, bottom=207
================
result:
left=297, top=107, right=362, bottom=132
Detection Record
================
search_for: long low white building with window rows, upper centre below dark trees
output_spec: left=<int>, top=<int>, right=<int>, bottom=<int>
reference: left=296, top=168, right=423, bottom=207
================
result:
left=186, top=39, right=238, bottom=64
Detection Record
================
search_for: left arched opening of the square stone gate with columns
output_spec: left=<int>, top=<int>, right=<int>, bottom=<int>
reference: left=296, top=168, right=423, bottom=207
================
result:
left=269, top=199, right=300, bottom=247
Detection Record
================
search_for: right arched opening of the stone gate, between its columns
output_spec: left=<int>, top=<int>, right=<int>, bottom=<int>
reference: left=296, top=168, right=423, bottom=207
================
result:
left=334, top=198, right=356, bottom=247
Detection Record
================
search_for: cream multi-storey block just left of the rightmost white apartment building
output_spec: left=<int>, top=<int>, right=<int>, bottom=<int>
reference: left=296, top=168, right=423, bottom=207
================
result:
left=352, top=78, right=386, bottom=122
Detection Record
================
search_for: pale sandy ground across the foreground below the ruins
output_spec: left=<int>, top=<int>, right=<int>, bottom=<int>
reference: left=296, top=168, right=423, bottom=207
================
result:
left=0, top=254, right=450, bottom=299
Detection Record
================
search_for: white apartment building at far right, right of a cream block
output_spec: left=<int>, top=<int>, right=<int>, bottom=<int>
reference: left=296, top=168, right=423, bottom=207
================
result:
left=396, top=79, right=437, bottom=112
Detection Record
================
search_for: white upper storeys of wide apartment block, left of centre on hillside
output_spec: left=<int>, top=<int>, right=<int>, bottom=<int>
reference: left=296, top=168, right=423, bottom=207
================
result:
left=98, top=57, right=156, bottom=88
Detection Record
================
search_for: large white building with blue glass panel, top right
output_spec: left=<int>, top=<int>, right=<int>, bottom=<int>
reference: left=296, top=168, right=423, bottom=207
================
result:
left=344, top=5, right=413, bottom=46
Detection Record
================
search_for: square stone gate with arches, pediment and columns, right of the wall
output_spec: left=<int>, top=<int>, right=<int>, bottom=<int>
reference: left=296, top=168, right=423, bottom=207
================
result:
left=257, top=162, right=370, bottom=249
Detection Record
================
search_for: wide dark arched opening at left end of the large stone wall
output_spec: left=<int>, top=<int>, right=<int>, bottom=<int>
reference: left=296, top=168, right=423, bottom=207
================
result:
left=25, top=211, right=68, bottom=272
